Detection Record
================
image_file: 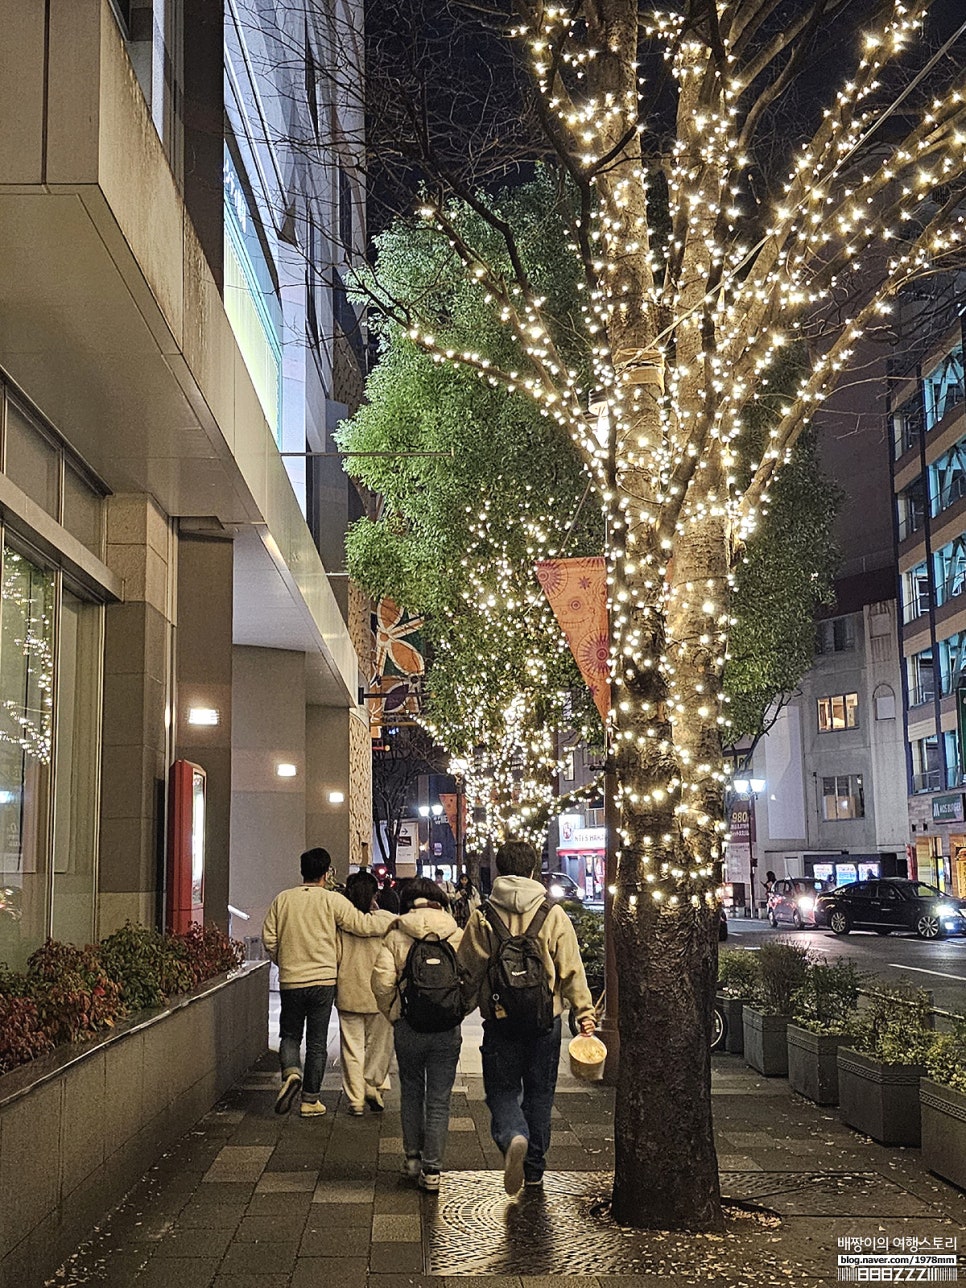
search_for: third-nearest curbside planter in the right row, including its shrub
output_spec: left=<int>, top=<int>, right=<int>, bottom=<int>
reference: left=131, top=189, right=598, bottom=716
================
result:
left=787, top=961, right=862, bottom=1105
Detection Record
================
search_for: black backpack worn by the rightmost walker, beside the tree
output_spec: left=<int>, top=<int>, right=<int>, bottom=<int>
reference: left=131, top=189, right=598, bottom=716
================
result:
left=483, top=899, right=554, bottom=1037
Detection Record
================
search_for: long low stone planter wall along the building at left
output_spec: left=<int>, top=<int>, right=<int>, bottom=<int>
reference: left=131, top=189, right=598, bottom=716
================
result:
left=0, top=962, right=268, bottom=1285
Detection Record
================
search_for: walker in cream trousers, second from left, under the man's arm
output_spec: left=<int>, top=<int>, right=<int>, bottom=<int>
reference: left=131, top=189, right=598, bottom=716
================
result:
left=335, top=872, right=395, bottom=1117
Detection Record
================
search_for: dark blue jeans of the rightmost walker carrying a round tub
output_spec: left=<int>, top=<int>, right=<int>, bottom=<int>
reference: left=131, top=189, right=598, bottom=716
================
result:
left=480, top=1015, right=560, bottom=1181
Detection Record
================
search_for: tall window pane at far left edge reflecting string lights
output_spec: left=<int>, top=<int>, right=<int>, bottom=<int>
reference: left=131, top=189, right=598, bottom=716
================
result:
left=0, top=546, right=54, bottom=969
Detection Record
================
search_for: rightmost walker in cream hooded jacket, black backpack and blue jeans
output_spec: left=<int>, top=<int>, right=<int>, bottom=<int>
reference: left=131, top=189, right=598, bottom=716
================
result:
left=457, top=841, right=596, bottom=1195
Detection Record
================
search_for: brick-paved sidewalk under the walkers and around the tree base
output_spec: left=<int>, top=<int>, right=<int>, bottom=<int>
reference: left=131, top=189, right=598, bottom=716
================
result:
left=47, top=1016, right=966, bottom=1288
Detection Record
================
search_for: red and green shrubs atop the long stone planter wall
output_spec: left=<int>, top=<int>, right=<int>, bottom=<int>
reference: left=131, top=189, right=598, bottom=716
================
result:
left=0, top=922, right=243, bottom=1073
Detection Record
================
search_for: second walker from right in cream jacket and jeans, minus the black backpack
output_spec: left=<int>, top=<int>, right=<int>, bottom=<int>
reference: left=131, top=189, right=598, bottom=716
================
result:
left=372, top=877, right=462, bottom=1191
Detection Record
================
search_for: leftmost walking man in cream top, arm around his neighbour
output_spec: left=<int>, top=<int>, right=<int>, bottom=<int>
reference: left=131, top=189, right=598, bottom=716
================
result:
left=261, top=846, right=385, bottom=1118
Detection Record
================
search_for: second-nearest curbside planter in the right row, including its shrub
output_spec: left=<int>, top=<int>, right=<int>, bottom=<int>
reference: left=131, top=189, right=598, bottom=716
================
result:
left=838, top=984, right=936, bottom=1145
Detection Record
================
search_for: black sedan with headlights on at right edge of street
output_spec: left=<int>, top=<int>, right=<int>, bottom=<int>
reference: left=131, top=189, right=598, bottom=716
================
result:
left=815, top=877, right=966, bottom=939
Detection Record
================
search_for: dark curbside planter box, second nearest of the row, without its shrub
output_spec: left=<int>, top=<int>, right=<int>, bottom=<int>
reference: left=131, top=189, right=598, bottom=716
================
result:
left=838, top=1047, right=926, bottom=1145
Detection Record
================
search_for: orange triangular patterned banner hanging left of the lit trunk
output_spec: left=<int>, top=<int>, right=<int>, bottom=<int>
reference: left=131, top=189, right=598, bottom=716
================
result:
left=536, top=556, right=611, bottom=724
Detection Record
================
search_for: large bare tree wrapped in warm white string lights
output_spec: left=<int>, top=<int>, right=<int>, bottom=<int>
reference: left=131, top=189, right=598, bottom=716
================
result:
left=358, top=0, right=966, bottom=1230
